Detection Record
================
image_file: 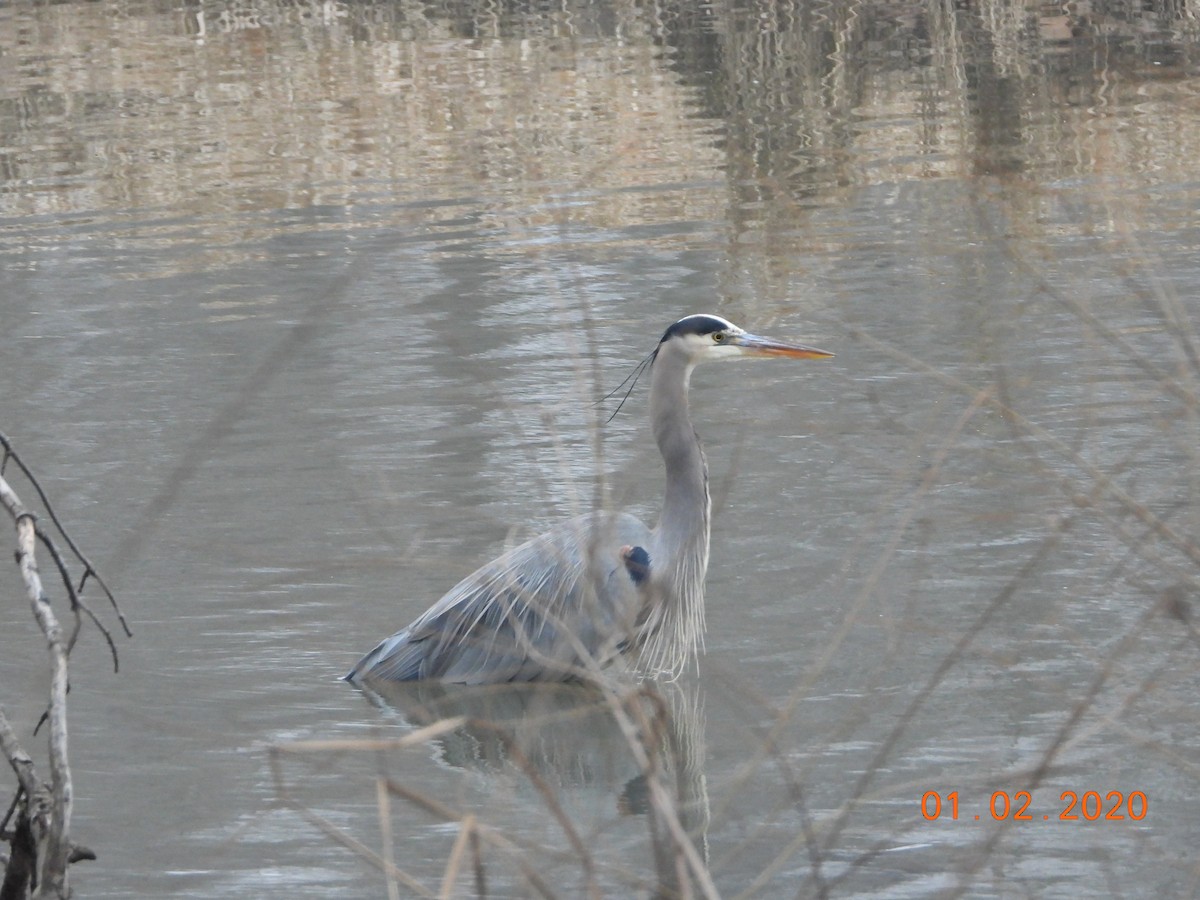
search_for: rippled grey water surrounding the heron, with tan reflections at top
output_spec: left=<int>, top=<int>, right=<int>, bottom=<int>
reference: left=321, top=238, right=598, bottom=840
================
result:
left=0, top=0, right=1200, bottom=898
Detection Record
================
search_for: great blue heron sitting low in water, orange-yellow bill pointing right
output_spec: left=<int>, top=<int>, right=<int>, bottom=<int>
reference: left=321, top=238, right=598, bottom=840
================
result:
left=346, top=314, right=833, bottom=684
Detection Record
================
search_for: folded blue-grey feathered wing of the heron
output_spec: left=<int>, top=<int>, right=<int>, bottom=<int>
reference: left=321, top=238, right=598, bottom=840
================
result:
left=349, top=515, right=649, bottom=684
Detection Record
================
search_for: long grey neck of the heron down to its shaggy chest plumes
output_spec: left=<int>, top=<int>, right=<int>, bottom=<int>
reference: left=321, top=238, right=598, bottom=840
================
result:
left=642, top=346, right=709, bottom=676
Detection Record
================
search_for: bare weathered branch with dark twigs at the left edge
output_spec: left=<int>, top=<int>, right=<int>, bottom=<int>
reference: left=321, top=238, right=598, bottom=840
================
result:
left=0, top=434, right=123, bottom=900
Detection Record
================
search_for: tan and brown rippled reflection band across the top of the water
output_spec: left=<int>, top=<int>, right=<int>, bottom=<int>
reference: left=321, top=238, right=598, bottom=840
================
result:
left=0, top=0, right=1200, bottom=221
